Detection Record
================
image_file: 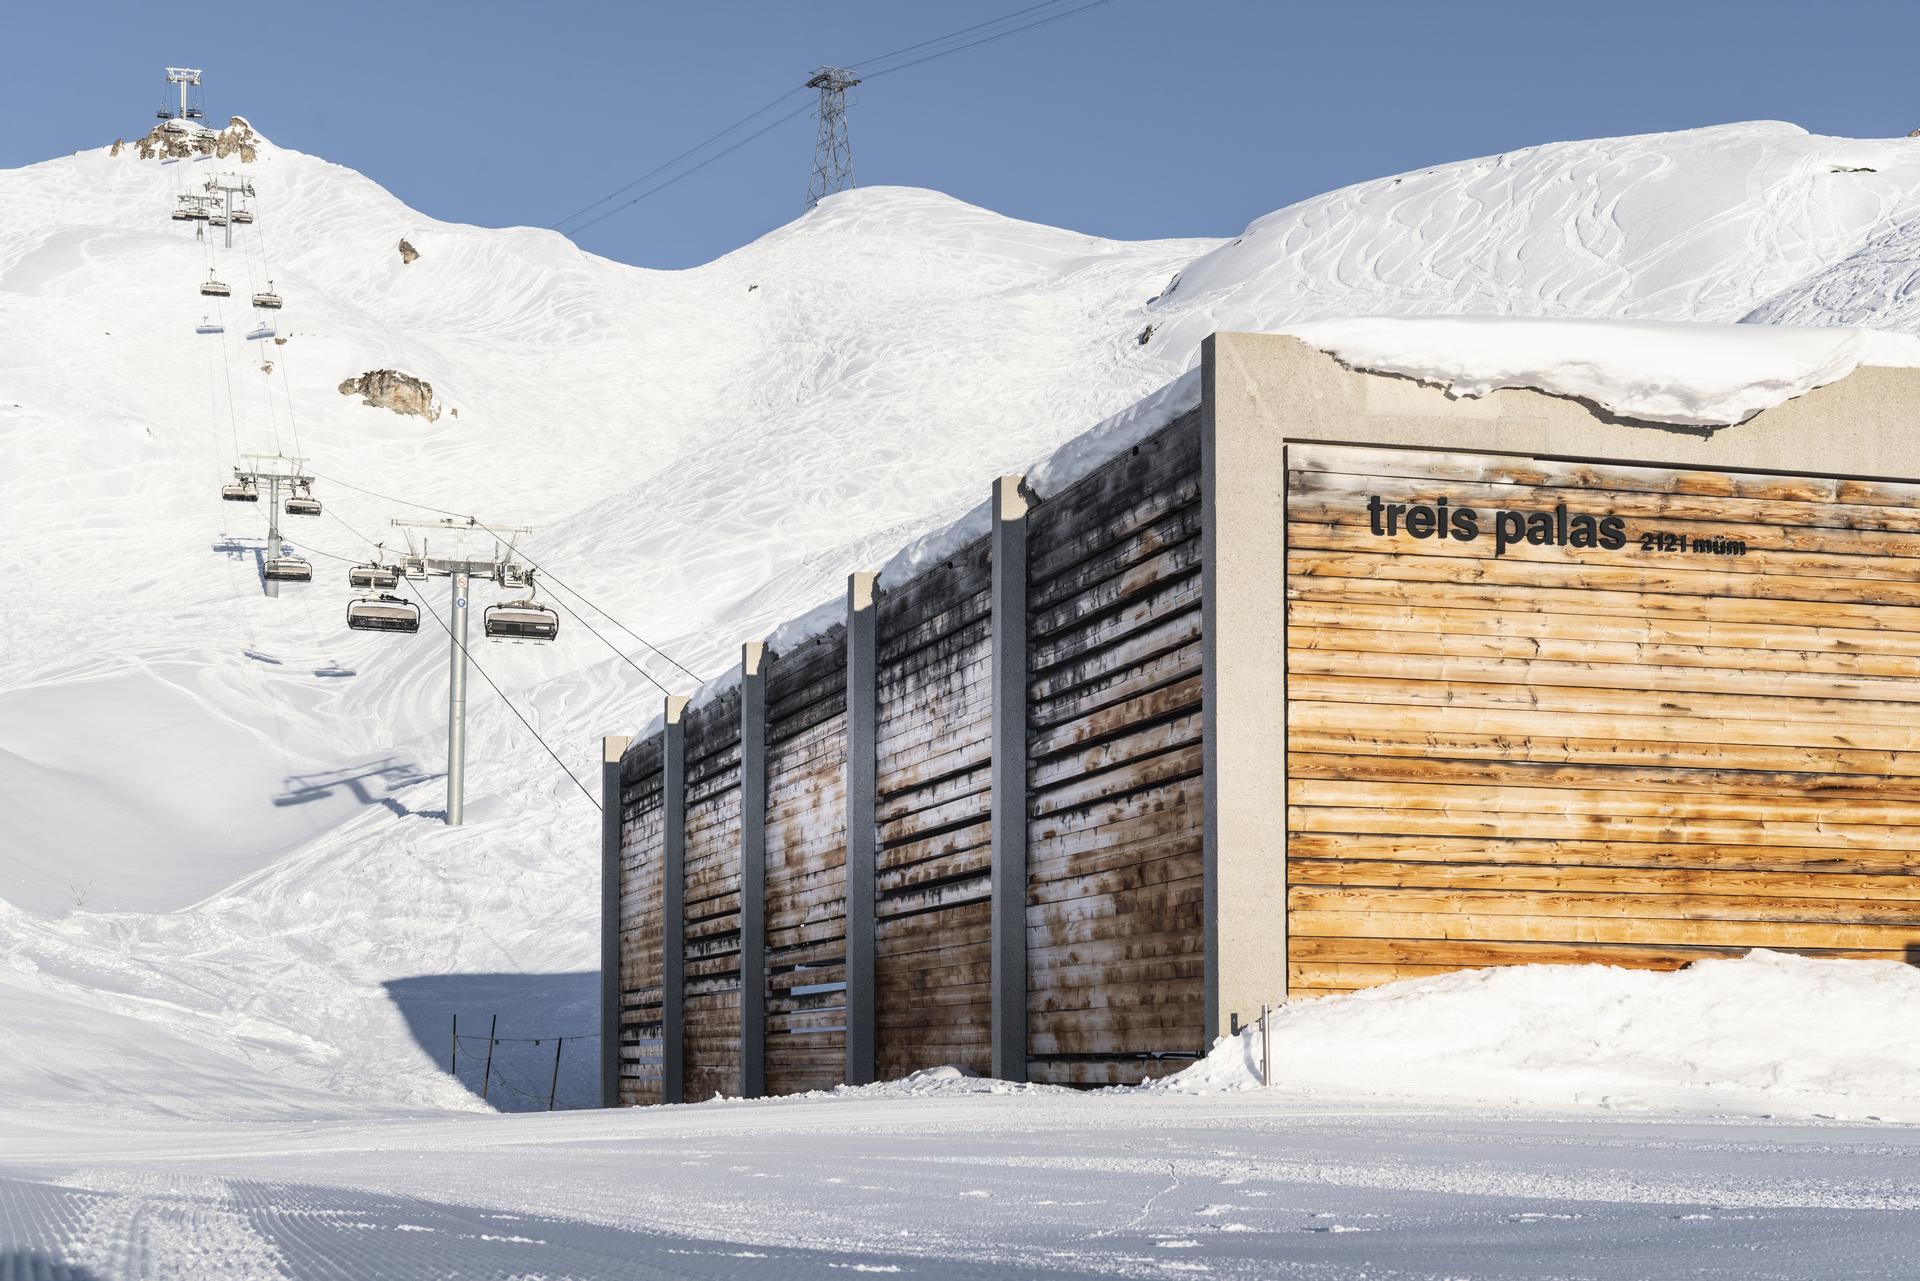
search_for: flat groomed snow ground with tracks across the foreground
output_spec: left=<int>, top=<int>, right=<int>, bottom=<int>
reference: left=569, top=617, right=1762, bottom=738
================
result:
left=0, top=1093, right=1920, bottom=1281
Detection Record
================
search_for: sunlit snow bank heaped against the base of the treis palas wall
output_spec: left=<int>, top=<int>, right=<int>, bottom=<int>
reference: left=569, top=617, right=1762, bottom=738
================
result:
left=1146, top=951, right=1920, bottom=1120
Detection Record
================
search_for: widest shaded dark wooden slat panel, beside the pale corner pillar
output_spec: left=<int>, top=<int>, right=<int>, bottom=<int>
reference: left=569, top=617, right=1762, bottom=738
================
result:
left=1027, top=411, right=1206, bottom=1085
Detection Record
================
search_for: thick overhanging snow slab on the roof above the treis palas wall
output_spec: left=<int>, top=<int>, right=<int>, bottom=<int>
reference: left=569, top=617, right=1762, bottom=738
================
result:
left=1286, top=317, right=1920, bottom=426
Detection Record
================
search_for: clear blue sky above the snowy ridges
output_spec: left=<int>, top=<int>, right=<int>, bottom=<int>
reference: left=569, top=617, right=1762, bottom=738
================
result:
left=15, top=0, right=1920, bottom=267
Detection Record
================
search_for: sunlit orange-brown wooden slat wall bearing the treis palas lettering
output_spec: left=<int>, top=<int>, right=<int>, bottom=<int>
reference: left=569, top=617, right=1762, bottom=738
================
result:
left=1288, top=446, right=1920, bottom=995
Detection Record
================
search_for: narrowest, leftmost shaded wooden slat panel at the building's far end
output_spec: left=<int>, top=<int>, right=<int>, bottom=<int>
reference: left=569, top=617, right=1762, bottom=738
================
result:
left=622, top=737, right=662, bottom=1106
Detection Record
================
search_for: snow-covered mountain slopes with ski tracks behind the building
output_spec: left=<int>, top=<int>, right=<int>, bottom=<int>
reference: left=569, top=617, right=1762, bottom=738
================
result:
left=0, top=123, right=1920, bottom=1116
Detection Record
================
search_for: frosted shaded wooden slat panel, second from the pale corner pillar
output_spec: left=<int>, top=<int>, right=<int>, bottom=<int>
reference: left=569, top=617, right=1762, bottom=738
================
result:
left=879, top=540, right=993, bottom=1079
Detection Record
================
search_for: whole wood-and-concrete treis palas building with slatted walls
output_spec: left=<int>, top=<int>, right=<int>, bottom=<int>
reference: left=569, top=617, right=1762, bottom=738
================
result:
left=603, top=334, right=1920, bottom=1104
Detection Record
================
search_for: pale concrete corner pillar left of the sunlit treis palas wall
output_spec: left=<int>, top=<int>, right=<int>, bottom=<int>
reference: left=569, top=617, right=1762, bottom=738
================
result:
left=1196, top=336, right=1286, bottom=1049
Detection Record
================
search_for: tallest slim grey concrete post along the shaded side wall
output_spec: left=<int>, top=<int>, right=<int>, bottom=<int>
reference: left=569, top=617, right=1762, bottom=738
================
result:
left=991, top=476, right=1027, bottom=1081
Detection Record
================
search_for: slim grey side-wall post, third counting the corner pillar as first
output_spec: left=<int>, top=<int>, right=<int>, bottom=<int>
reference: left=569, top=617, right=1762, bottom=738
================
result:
left=845, top=574, right=879, bottom=1085
